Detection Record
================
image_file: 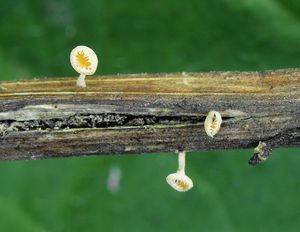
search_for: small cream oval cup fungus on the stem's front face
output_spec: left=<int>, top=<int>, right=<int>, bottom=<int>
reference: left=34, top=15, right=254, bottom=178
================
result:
left=204, top=110, right=222, bottom=138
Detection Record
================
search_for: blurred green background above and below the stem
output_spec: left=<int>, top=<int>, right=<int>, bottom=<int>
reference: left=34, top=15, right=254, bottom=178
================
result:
left=0, top=0, right=300, bottom=232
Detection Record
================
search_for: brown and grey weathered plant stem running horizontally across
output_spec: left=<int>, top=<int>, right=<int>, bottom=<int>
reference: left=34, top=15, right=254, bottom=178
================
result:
left=0, top=70, right=300, bottom=160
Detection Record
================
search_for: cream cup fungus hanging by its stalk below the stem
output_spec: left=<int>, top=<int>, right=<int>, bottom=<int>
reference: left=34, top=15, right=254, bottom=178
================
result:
left=166, top=151, right=193, bottom=192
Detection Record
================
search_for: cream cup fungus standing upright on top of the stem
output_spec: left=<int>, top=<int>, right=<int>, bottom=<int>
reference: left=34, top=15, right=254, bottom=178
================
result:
left=70, top=46, right=98, bottom=88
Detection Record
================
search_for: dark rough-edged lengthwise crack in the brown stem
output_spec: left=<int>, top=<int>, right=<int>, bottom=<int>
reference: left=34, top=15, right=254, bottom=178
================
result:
left=0, top=114, right=210, bottom=134
